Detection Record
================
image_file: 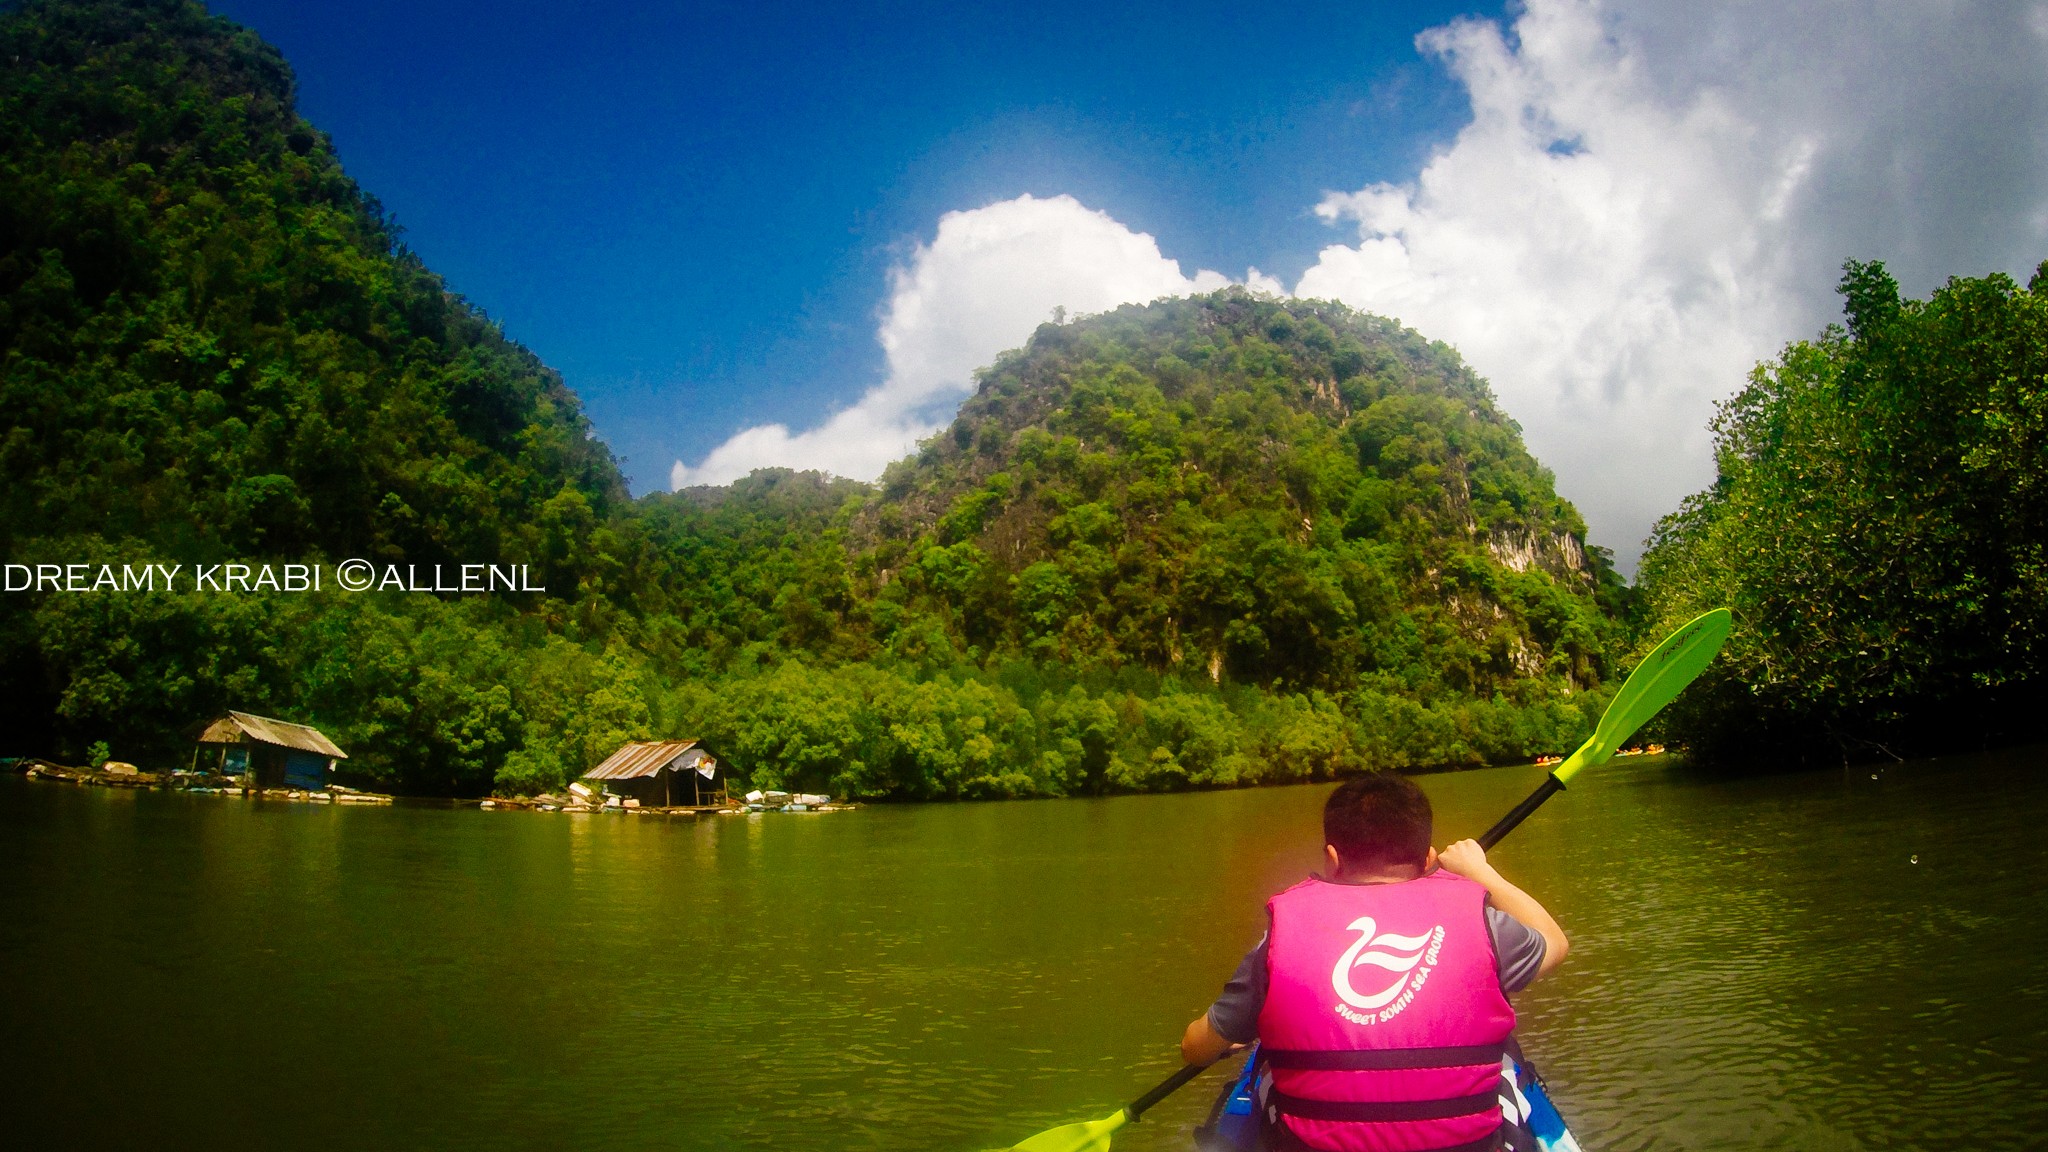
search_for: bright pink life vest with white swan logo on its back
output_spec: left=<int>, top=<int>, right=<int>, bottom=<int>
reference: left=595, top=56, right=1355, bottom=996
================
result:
left=1260, top=869, right=1516, bottom=1152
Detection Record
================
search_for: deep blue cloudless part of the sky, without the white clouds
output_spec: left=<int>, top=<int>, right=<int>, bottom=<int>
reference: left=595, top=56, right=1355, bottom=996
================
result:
left=215, top=0, right=1489, bottom=492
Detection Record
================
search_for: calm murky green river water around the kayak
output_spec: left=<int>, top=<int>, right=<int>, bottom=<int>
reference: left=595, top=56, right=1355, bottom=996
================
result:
left=0, top=737, right=2048, bottom=1152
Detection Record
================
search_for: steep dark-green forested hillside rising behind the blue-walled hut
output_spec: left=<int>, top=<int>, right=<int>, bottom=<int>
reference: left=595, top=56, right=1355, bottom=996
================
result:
left=0, top=4, right=625, bottom=787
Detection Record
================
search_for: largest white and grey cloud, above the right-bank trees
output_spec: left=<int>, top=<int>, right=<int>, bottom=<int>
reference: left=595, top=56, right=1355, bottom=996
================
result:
left=1294, top=0, right=2048, bottom=568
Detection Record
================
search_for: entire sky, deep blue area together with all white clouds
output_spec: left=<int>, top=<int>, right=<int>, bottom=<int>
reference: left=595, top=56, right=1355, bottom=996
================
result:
left=219, top=0, right=2048, bottom=572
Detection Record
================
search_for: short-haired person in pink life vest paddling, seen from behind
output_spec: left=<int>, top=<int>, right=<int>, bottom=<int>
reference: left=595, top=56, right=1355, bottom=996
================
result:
left=1180, top=773, right=1571, bottom=1152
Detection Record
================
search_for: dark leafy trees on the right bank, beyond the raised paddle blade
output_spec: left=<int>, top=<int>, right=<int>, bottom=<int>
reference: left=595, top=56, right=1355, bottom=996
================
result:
left=1638, top=262, right=2048, bottom=763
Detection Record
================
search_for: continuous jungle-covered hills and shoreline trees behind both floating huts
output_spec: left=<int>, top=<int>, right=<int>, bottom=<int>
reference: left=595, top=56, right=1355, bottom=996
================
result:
left=0, top=0, right=1624, bottom=797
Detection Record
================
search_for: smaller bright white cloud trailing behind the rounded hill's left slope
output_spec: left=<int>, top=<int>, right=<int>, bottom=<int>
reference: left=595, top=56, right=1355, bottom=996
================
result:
left=670, top=197, right=1229, bottom=488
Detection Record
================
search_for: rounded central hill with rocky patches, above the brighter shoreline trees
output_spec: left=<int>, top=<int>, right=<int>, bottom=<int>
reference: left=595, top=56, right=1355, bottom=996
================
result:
left=850, top=289, right=1614, bottom=699
